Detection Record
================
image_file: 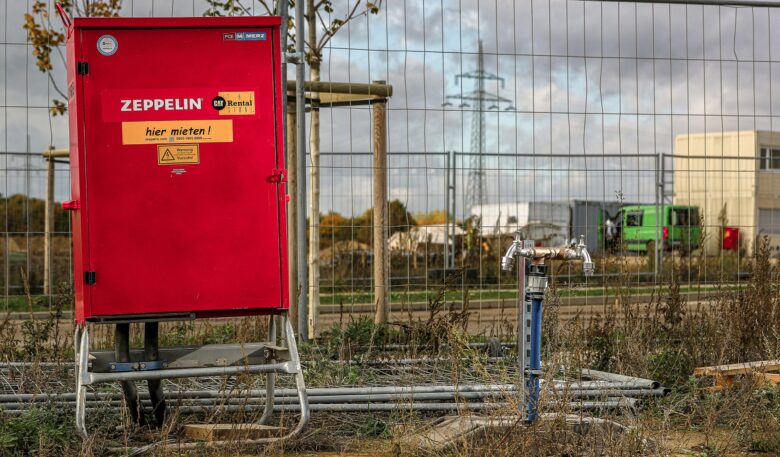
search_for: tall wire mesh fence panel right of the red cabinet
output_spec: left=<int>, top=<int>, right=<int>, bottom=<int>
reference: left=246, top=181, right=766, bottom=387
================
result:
left=309, top=1, right=777, bottom=338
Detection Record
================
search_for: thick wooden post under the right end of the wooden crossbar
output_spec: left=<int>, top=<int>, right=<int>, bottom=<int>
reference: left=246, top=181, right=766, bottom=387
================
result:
left=371, top=81, right=390, bottom=324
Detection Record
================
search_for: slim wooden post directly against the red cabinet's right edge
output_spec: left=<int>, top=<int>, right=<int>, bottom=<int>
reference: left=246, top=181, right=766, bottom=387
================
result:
left=287, top=101, right=298, bottom=330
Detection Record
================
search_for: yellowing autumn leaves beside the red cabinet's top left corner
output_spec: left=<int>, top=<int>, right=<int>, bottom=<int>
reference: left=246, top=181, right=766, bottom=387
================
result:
left=23, top=0, right=122, bottom=116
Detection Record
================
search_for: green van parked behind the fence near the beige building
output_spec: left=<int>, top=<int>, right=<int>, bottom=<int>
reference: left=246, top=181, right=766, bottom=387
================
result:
left=604, top=205, right=701, bottom=254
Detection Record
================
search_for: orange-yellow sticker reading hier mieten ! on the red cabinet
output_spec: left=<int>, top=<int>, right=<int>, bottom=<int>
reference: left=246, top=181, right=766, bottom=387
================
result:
left=122, top=120, right=233, bottom=144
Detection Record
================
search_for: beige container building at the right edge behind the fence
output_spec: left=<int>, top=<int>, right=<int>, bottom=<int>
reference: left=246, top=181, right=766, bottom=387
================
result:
left=673, top=131, right=780, bottom=255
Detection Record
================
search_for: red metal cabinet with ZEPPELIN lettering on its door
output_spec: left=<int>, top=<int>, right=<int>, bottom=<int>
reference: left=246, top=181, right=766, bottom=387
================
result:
left=63, top=17, right=288, bottom=323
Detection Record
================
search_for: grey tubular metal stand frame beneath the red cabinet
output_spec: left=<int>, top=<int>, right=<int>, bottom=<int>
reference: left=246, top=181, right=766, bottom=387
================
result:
left=73, top=313, right=310, bottom=445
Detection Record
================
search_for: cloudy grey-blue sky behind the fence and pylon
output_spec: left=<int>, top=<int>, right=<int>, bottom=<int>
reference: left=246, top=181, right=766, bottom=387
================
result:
left=0, top=0, right=780, bottom=215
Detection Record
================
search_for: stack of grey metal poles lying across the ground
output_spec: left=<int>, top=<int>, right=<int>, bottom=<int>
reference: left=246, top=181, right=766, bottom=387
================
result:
left=0, top=370, right=668, bottom=415
